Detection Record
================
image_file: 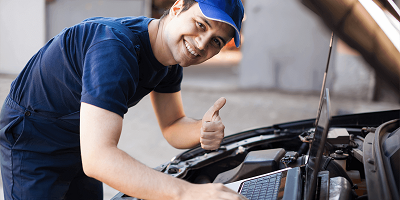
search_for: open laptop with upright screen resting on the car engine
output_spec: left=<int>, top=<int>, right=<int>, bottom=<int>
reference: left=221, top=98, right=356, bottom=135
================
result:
left=225, top=34, right=333, bottom=200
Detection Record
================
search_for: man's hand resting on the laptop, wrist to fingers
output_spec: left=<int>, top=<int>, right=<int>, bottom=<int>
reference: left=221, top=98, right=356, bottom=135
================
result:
left=180, top=183, right=248, bottom=200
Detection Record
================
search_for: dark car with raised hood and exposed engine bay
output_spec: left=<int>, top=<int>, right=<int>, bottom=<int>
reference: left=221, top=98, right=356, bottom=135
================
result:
left=112, top=0, right=400, bottom=200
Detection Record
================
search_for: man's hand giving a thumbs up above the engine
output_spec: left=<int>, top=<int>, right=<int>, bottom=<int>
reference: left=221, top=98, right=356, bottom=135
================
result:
left=200, top=97, right=226, bottom=150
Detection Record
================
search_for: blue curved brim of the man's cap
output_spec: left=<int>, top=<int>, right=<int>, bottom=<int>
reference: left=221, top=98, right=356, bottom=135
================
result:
left=198, top=2, right=240, bottom=47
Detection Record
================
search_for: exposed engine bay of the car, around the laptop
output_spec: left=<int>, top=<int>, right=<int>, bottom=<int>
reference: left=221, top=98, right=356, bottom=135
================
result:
left=113, top=110, right=400, bottom=199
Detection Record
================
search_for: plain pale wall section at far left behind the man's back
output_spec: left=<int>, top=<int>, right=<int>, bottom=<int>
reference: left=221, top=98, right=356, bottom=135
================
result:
left=0, top=0, right=45, bottom=74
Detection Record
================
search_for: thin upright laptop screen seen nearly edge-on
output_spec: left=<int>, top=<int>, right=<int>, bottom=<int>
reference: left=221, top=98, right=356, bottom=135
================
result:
left=304, top=88, right=331, bottom=200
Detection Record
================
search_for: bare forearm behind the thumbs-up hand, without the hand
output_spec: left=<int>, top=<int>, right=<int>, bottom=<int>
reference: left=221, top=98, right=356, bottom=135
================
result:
left=162, top=117, right=202, bottom=149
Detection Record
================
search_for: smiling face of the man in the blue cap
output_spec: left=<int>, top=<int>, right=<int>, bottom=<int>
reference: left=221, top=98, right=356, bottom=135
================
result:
left=160, top=0, right=234, bottom=67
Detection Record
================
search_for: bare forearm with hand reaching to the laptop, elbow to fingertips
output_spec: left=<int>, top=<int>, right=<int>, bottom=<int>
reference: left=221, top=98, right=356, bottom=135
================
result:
left=82, top=138, right=245, bottom=200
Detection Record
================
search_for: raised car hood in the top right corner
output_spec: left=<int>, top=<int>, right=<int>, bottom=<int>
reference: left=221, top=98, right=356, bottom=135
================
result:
left=302, top=0, right=400, bottom=93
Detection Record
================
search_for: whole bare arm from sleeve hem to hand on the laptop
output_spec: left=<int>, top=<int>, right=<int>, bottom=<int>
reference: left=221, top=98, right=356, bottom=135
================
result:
left=80, top=103, right=244, bottom=200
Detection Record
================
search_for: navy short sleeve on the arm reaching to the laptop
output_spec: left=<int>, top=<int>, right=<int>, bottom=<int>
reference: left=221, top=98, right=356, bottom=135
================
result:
left=81, top=39, right=139, bottom=117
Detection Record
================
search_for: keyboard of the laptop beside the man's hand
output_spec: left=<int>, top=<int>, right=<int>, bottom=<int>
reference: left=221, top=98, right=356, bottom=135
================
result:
left=240, top=172, right=282, bottom=200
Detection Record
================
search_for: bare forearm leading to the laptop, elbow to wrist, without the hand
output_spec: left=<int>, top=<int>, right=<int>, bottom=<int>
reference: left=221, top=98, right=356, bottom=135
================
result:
left=83, top=147, right=190, bottom=199
